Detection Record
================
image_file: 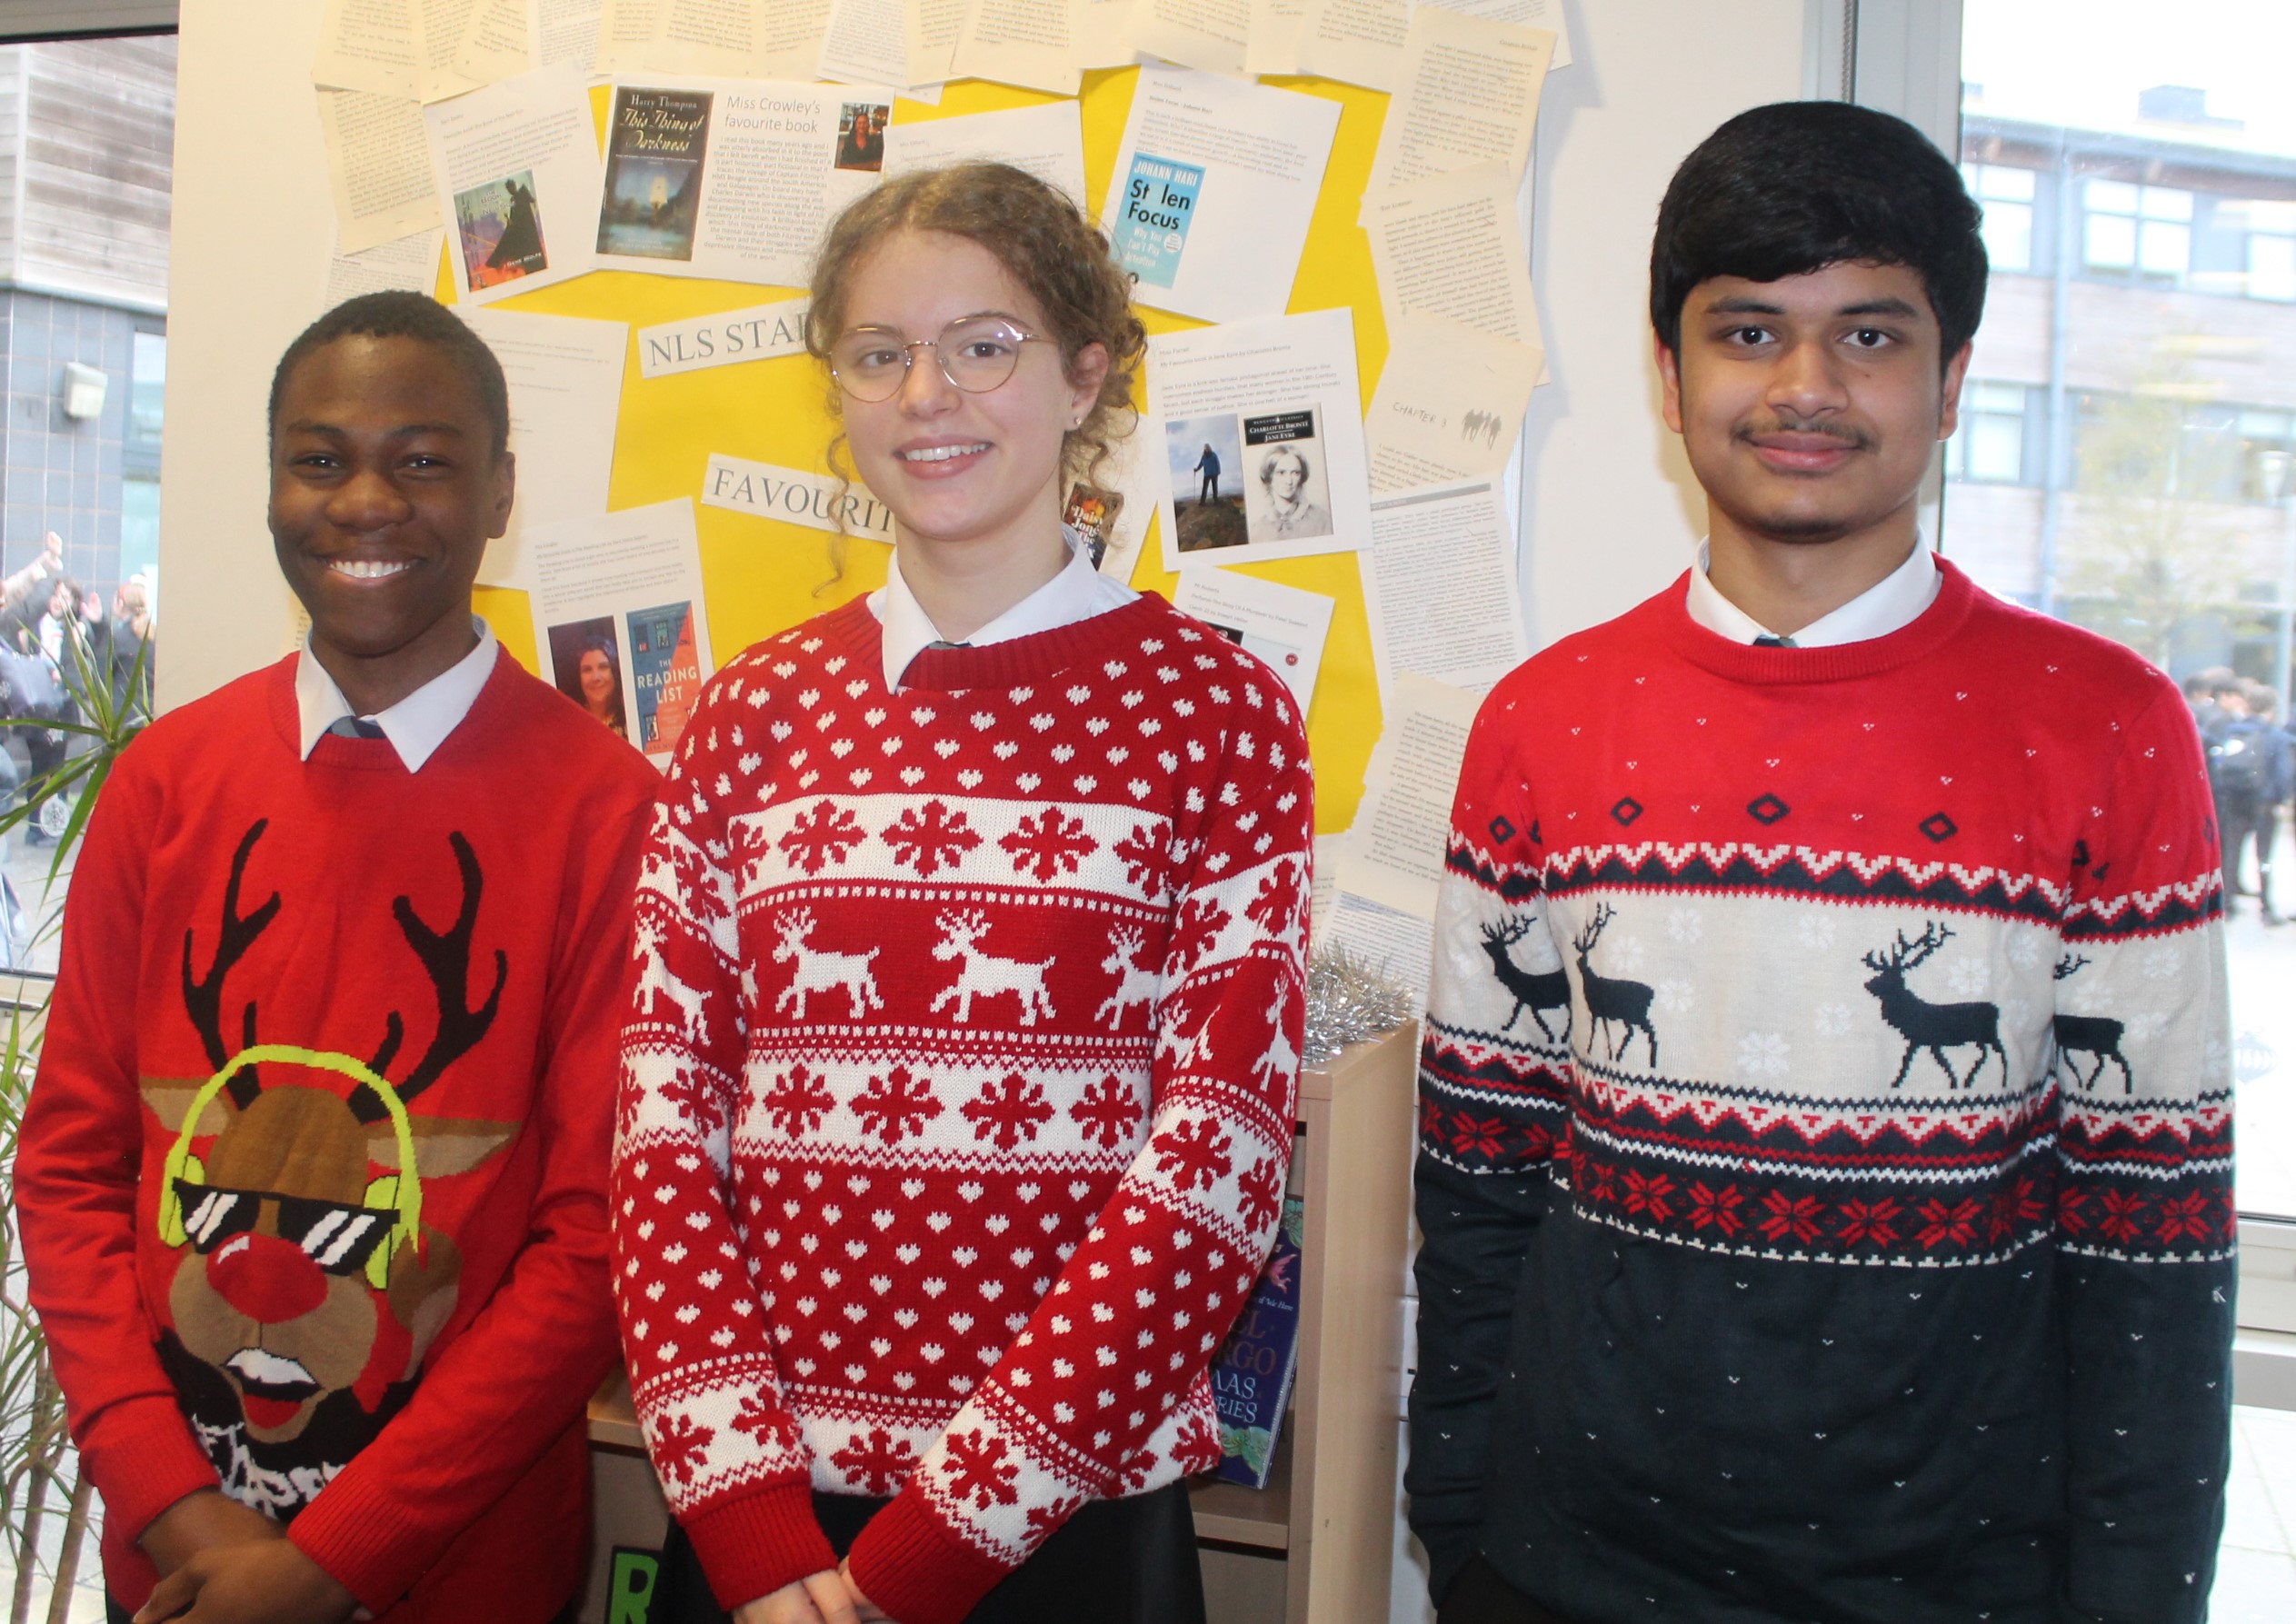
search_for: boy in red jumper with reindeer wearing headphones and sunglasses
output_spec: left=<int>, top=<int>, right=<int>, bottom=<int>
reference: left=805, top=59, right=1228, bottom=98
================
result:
left=16, top=294, right=654, bottom=1624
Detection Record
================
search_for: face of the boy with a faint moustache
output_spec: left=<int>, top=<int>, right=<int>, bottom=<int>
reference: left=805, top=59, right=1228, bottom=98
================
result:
left=1658, top=264, right=1970, bottom=544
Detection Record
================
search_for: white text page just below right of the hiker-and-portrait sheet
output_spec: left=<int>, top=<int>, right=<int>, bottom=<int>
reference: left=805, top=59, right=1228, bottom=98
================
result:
left=1359, top=480, right=1532, bottom=702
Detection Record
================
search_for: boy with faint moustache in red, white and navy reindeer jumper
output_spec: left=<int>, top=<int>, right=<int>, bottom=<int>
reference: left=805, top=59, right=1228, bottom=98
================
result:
left=1410, top=104, right=2234, bottom=1624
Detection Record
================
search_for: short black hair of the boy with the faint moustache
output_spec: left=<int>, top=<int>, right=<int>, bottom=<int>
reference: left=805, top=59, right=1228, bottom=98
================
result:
left=1651, top=101, right=1986, bottom=361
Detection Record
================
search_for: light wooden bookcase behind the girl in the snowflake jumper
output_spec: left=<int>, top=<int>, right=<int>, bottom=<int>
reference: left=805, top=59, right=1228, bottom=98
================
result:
left=584, top=1027, right=1419, bottom=1624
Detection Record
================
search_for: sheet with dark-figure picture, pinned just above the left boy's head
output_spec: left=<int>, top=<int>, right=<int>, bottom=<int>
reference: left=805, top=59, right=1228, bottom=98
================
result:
left=424, top=62, right=597, bottom=304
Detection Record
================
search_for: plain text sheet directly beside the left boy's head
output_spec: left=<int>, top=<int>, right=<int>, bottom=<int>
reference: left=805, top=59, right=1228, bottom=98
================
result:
left=457, top=308, right=629, bottom=591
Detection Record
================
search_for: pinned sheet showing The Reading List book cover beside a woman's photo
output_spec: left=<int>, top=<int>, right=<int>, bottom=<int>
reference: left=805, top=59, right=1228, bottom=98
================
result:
left=531, top=496, right=716, bottom=765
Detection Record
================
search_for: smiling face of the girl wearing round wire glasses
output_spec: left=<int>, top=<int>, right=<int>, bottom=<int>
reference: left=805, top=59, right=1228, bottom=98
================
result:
left=843, top=232, right=1107, bottom=556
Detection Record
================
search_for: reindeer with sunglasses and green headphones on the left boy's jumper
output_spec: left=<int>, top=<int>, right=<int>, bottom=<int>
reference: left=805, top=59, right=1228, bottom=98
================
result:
left=143, top=820, right=516, bottom=1520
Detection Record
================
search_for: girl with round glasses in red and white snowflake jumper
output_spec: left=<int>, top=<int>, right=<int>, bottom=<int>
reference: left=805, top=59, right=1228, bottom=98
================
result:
left=613, top=163, right=1311, bottom=1624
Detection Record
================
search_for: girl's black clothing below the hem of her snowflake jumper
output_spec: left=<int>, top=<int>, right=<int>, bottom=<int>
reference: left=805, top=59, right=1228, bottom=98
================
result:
left=650, top=1484, right=1203, bottom=1624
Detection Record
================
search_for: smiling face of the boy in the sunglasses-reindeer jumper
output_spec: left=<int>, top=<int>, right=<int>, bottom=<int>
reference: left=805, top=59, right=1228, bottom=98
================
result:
left=271, top=335, right=512, bottom=712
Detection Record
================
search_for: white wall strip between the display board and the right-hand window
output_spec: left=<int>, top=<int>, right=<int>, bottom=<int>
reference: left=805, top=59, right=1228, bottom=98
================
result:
left=1522, top=0, right=1807, bottom=645
